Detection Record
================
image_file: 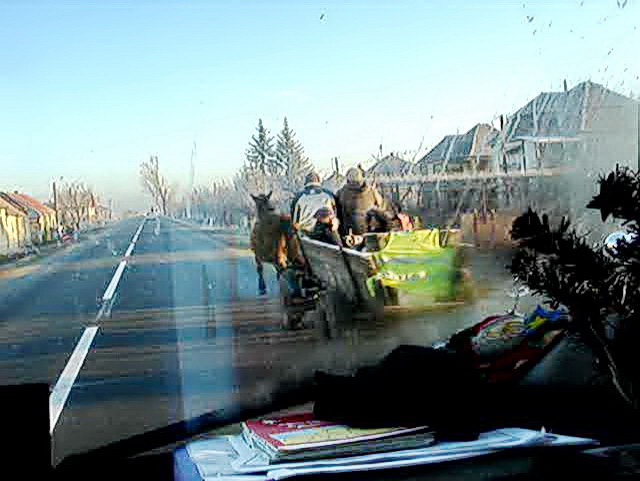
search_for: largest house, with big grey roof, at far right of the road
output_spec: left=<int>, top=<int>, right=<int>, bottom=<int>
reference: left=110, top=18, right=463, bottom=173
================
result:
left=492, top=81, right=638, bottom=172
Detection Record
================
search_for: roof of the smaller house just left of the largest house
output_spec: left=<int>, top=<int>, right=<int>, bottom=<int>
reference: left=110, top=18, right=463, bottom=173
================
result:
left=416, top=124, right=497, bottom=168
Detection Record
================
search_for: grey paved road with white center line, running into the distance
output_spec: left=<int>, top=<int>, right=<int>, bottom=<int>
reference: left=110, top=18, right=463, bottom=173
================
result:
left=0, top=217, right=536, bottom=461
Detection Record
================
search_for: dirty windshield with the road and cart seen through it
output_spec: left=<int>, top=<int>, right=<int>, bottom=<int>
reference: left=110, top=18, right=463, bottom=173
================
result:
left=0, top=0, right=640, bottom=462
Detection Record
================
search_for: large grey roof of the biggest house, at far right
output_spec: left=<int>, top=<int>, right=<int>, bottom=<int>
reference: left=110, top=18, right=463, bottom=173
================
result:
left=504, top=81, right=635, bottom=142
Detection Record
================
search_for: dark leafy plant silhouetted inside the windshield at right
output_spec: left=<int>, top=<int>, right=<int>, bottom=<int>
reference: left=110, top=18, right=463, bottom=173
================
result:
left=510, top=167, right=640, bottom=407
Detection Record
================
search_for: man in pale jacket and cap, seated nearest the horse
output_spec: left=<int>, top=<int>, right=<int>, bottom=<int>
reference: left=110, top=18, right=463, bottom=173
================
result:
left=291, top=172, right=337, bottom=235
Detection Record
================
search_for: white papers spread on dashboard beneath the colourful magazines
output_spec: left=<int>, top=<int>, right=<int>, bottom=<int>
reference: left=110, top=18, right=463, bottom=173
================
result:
left=186, top=428, right=597, bottom=481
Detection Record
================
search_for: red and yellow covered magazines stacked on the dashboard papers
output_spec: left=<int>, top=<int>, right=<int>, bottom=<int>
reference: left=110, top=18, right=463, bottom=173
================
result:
left=243, top=412, right=427, bottom=451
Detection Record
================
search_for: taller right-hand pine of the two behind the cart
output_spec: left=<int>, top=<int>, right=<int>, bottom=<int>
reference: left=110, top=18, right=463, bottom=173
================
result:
left=275, top=117, right=313, bottom=191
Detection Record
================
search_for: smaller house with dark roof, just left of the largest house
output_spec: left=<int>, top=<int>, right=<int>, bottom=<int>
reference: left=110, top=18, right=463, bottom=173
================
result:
left=413, top=124, right=498, bottom=175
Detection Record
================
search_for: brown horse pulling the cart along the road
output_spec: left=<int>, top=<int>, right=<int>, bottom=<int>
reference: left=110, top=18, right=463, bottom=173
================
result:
left=251, top=192, right=304, bottom=295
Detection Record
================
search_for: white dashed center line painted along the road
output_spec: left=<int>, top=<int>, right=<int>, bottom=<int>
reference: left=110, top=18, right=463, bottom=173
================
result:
left=49, top=219, right=146, bottom=433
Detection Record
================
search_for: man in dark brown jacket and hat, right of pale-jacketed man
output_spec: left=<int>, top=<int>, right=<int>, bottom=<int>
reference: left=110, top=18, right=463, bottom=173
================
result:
left=337, top=167, right=387, bottom=235
